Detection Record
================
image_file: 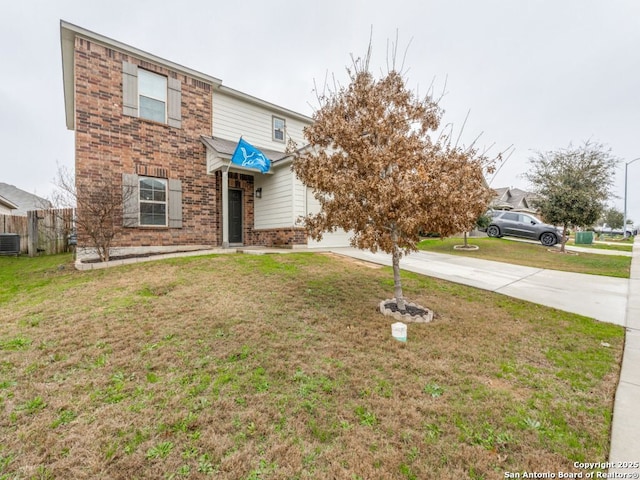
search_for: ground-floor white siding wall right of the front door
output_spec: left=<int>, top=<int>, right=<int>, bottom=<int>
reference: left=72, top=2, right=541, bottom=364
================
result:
left=254, top=167, right=293, bottom=229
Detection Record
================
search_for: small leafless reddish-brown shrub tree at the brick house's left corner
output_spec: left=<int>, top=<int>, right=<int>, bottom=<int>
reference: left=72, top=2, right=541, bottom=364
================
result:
left=53, top=166, right=134, bottom=262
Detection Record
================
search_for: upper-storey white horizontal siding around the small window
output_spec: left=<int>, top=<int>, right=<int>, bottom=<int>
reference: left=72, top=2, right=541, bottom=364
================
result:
left=212, top=91, right=306, bottom=151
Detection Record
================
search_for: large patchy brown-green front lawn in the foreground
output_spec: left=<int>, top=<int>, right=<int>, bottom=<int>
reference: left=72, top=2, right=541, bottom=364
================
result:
left=0, top=253, right=624, bottom=480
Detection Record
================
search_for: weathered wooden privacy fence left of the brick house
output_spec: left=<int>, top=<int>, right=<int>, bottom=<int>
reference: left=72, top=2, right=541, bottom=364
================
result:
left=0, top=208, right=75, bottom=257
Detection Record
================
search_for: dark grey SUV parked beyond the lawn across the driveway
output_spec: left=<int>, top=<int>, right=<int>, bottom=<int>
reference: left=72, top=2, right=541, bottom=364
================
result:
left=486, top=210, right=562, bottom=247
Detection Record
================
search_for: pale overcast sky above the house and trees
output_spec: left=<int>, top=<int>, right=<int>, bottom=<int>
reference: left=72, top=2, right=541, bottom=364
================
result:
left=0, top=0, right=640, bottom=223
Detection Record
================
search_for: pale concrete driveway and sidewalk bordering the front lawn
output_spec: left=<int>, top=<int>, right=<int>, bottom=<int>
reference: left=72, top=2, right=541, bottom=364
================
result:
left=331, top=246, right=640, bottom=470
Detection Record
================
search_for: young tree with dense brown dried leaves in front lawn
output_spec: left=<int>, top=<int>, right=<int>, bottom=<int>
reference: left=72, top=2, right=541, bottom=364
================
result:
left=293, top=50, right=493, bottom=312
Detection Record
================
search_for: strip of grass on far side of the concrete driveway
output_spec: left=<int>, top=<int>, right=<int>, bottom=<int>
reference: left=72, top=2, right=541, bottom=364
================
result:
left=418, top=237, right=631, bottom=278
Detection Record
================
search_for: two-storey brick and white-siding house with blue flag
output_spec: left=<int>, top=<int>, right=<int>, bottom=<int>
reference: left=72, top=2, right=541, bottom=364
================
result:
left=60, top=21, right=348, bottom=255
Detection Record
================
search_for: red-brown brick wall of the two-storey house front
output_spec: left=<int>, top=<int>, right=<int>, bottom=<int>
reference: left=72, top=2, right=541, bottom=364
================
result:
left=75, top=37, right=220, bottom=247
